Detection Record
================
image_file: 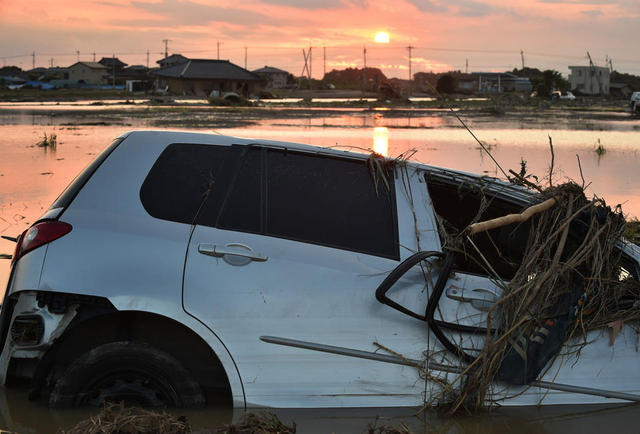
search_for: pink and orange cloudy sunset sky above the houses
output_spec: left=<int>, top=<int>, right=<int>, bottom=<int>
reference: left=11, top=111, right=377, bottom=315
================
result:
left=0, top=0, right=640, bottom=78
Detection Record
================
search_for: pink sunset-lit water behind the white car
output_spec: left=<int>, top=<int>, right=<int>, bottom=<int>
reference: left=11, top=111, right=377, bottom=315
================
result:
left=0, top=113, right=640, bottom=298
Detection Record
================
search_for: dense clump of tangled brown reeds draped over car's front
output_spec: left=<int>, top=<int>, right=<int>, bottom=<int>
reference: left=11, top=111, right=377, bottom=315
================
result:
left=450, top=183, right=640, bottom=411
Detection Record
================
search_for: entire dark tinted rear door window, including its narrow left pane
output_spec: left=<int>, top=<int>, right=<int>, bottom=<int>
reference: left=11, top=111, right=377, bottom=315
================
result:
left=204, top=147, right=400, bottom=259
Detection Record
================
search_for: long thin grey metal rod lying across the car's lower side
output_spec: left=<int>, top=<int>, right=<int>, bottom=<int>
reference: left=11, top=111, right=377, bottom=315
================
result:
left=260, top=336, right=640, bottom=402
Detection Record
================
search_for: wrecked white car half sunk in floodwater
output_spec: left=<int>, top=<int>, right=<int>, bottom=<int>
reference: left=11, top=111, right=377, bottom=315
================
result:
left=0, top=131, right=640, bottom=407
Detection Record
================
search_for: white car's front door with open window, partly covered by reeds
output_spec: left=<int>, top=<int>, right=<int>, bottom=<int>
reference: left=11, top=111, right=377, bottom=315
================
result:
left=370, top=170, right=528, bottom=403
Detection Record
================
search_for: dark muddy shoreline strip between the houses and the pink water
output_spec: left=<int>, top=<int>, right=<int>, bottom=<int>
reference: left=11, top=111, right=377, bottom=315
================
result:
left=0, top=95, right=640, bottom=131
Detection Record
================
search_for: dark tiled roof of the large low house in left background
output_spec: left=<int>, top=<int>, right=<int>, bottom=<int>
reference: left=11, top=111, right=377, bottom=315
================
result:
left=152, top=59, right=262, bottom=81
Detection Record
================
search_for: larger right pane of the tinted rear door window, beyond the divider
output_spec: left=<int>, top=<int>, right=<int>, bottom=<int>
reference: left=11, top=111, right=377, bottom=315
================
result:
left=265, top=150, right=399, bottom=259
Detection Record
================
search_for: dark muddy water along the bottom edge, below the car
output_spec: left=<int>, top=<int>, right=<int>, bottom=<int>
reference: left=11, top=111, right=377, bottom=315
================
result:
left=0, top=387, right=640, bottom=434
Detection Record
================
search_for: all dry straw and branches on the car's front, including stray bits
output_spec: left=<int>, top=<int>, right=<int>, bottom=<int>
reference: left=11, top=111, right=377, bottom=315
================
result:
left=370, top=142, right=640, bottom=413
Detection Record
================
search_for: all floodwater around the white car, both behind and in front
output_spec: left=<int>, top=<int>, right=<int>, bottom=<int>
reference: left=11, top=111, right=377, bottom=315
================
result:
left=0, top=102, right=640, bottom=433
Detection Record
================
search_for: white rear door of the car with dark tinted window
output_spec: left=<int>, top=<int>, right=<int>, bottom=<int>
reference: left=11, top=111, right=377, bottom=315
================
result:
left=183, top=146, right=436, bottom=407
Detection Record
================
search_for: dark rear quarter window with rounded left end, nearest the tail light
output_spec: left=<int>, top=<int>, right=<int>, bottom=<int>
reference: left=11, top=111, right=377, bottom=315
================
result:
left=140, top=143, right=240, bottom=224
